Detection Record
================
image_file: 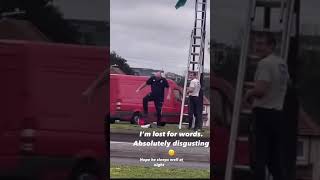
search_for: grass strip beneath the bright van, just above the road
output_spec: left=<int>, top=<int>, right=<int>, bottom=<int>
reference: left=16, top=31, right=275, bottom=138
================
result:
left=110, top=122, right=210, bottom=137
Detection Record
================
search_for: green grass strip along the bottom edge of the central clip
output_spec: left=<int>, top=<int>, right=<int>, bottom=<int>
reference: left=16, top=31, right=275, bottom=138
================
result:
left=110, top=165, right=210, bottom=179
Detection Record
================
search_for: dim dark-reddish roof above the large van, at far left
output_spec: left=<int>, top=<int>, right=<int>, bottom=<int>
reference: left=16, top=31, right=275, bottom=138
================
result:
left=0, top=18, right=50, bottom=42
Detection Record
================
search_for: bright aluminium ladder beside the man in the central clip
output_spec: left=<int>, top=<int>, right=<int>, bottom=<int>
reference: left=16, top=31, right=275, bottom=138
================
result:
left=179, top=0, right=207, bottom=129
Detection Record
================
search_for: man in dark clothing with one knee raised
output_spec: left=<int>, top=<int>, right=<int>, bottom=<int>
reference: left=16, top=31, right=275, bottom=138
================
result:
left=136, top=72, right=171, bottom=127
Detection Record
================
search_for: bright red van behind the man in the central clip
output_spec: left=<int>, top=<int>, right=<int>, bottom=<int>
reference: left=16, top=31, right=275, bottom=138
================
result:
left=110, top=74, right=187, bottom=123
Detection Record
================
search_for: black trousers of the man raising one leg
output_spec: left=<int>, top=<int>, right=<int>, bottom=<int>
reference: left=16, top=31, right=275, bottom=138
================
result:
left=143, top=93, right=163, bottom=125
